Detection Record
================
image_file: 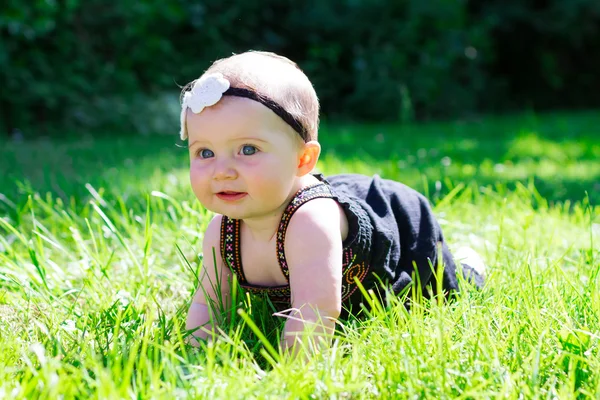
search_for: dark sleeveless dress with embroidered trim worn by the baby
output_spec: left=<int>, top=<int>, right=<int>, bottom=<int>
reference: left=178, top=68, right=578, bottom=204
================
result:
left=221, top=174, right=483, bottom=317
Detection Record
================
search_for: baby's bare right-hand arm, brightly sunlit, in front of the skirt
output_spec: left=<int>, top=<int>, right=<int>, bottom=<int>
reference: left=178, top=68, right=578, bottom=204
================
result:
left=282, top=199, right=343, bottom=351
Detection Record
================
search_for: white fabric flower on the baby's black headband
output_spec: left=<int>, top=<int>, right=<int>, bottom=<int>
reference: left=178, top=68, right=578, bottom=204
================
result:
left=180, top=73, right=230, bottom=140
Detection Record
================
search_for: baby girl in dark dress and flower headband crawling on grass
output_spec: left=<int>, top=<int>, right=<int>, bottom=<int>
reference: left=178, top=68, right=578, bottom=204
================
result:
left=181, top=52, right=484, bottom=348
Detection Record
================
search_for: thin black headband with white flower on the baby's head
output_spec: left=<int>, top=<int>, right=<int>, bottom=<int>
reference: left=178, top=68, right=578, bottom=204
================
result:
left=180, top=73, right=309, bottom=142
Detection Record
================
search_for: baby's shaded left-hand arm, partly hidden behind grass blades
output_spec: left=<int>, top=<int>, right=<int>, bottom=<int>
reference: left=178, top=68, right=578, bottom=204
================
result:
left=186, top=215, right=230, bottom=346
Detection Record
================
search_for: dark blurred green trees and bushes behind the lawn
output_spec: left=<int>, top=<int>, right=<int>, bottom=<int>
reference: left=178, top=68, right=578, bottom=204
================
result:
left=0, top=0, right=600, bottom=137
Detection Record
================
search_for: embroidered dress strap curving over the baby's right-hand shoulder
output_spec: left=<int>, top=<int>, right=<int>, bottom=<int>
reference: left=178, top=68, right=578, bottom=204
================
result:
left=277, top=183, right=334, bottom=282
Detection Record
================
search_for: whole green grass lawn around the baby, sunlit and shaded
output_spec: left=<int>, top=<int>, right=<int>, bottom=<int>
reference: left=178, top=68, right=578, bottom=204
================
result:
left=0, top=112, right=600, bottom=399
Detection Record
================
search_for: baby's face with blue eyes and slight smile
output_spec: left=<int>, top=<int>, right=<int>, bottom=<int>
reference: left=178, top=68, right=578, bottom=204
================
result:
left=186, top=96, right=302, bottom=219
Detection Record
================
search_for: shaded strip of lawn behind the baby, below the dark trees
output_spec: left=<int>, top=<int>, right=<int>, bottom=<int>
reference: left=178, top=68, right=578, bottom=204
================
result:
left=0, top=112, right=600, bottom=219
